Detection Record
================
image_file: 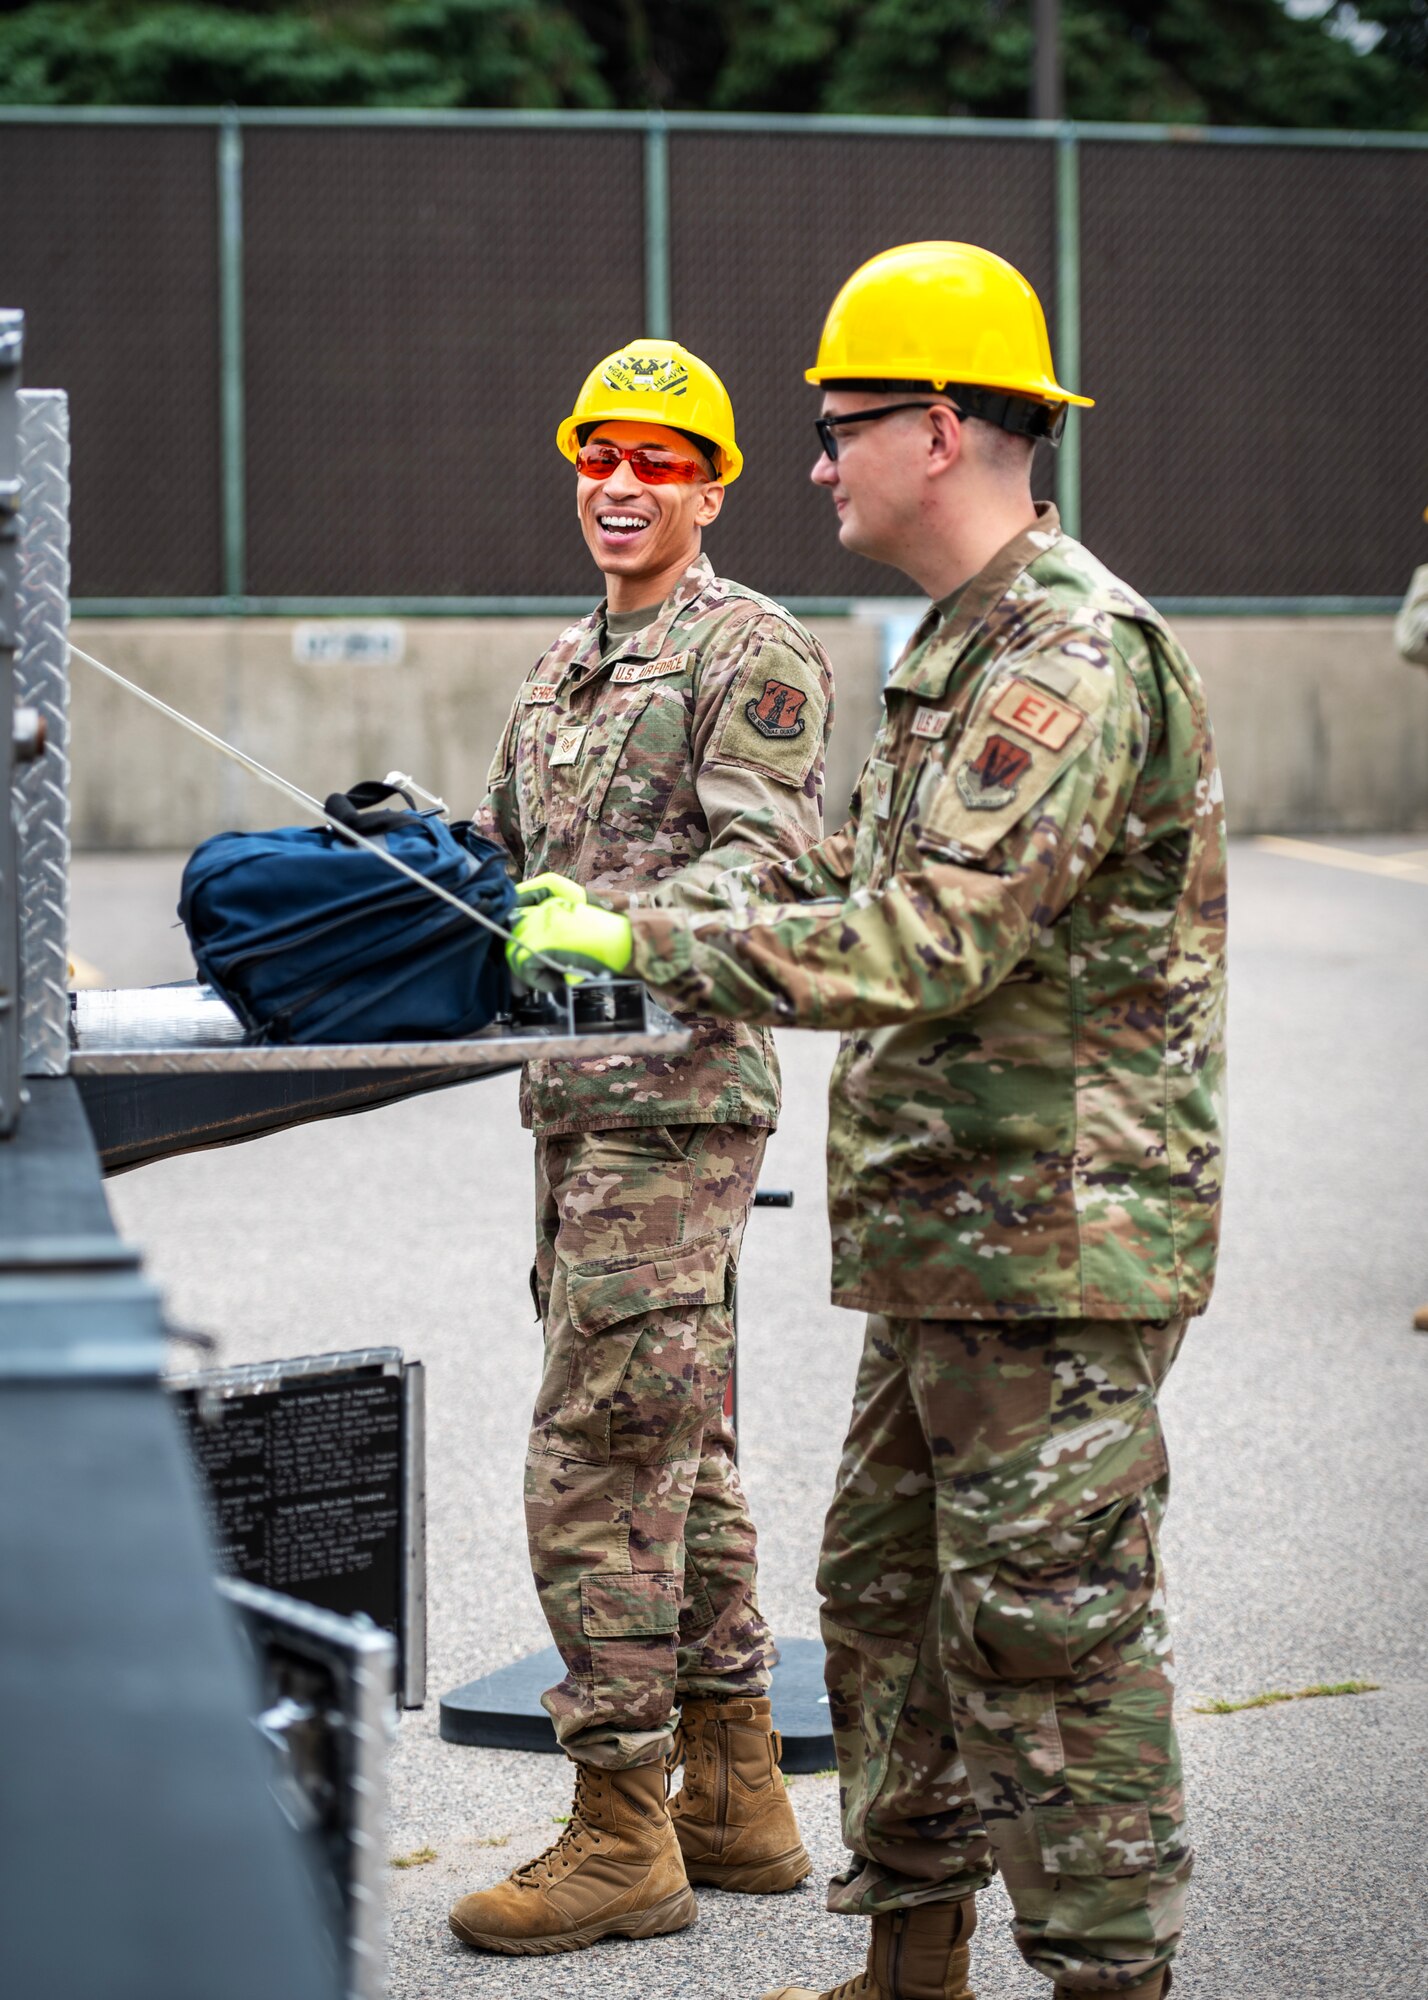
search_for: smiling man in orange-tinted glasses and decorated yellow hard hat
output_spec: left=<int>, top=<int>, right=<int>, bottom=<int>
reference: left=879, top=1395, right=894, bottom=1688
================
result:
left=452, top=340, right=832, bottom=1952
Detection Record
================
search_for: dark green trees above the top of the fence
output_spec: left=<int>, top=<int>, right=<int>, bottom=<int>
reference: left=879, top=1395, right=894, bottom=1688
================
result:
left=0, top=0, right=1428, bottom=128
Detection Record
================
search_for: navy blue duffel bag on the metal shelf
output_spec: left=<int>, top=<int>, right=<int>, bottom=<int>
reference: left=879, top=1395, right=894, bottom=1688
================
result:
left=178, top=782, right=516, bottom=1042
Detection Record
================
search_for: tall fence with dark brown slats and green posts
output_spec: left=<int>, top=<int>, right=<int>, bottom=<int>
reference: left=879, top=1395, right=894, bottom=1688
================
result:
left=0, top=112, right=1428, bottom=610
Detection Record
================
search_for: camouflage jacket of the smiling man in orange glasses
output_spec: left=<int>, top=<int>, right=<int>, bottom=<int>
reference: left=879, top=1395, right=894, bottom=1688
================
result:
left=476, top=556, right=832, bottom=1132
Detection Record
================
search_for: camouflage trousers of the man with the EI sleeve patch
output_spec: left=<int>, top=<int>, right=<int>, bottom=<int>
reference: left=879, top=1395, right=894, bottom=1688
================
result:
left=818, top=1314, right=1190, bottom=1992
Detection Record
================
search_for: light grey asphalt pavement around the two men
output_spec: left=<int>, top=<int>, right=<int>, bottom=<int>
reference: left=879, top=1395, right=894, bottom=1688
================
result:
left=92, top=840, right=1428, bottom=2000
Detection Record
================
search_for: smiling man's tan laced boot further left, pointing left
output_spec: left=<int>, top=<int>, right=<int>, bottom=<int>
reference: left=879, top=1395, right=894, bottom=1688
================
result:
left=450, top=1764, right=700, bottom=1956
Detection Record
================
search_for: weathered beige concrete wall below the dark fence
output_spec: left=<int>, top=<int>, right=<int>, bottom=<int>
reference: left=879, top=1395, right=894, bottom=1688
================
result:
left=72, top=616, right=1428, bottom=848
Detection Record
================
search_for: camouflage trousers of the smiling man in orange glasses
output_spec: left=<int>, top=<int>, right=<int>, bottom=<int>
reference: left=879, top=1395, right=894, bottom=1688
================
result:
left=526, top=1124, right=772, bottom=1768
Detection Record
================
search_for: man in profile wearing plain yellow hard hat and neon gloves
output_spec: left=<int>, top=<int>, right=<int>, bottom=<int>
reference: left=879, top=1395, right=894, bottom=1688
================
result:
left=508, top=242, right=1224, bottom=2000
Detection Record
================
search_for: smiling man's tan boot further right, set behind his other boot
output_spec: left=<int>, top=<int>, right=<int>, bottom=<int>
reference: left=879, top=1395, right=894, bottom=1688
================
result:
left=670, top=1694, right=814, bottom=1896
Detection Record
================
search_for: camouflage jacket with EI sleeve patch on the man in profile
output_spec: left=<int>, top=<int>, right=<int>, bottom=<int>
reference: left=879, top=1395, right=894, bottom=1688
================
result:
left=634, top=506, right=1226, bottom=1320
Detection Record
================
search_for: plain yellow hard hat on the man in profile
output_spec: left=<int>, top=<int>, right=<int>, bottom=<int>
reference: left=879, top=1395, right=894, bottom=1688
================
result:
left=804, top=242, right=1092, bottom=444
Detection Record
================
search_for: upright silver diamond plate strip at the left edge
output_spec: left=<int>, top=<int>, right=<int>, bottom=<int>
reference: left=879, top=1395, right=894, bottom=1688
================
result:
left=16, top=388, right=70, bottom=1076
